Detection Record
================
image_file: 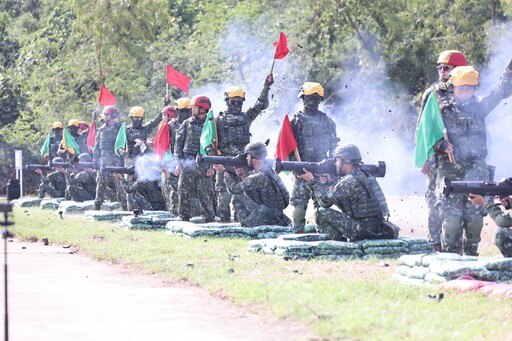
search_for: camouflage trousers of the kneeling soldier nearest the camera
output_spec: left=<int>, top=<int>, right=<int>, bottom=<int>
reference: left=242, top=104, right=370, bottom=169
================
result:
left=315, top=207, right=394, bottom=241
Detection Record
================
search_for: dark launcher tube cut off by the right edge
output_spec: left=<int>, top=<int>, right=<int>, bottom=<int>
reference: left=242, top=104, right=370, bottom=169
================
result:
left=443, top=178, right=512, bottom=197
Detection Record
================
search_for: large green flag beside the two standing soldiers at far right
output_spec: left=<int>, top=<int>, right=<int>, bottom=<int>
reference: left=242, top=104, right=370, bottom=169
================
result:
left=414, top=92, right=445, bottom=168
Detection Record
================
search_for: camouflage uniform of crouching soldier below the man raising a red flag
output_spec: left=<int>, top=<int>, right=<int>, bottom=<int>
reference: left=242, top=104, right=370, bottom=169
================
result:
left=224, top=168, right=291, bottom=227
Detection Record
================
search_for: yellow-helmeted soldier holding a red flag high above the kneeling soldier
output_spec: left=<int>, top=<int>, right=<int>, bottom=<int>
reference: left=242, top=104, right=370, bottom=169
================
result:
left=206, top=74, right=274, bottom=222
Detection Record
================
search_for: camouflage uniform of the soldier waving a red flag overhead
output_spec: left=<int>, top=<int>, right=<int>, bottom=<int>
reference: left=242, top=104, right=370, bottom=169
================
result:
left=206, top=84, right=270, bottom=221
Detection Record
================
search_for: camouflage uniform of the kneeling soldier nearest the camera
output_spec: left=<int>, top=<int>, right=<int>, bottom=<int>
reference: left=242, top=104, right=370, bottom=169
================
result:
left=309, top=169, right=394, bottom=241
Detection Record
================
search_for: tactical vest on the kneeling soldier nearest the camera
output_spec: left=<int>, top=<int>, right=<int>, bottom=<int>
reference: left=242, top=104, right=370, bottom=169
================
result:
left=343, top=172, right=389, bottom=219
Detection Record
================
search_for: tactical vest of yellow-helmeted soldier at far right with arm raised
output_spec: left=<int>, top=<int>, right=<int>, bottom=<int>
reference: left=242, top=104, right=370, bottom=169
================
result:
left=443, top=101, right=487, bottom=162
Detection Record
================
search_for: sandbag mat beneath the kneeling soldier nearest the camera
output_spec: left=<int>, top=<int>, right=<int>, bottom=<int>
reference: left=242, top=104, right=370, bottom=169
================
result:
left=247, top=233, right=430, bottom=260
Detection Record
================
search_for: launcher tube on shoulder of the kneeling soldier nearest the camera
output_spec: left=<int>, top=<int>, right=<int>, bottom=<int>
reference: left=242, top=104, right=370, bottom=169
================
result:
left=275, top=158, right=386, bottom=178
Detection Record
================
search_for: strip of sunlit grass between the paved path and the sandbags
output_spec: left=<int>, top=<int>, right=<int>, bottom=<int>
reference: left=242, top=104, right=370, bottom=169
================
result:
left=12, top=208, right=512, bottom=340
